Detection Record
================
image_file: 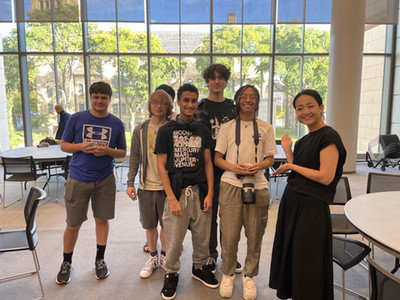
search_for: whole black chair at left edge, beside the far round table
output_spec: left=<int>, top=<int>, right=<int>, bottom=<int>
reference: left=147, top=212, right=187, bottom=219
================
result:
left=2, top=156, right=47, bottom=208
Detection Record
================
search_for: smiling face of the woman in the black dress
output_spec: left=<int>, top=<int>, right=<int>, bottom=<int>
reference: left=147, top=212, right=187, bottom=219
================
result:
left=295, top=95, right=324, bottom=131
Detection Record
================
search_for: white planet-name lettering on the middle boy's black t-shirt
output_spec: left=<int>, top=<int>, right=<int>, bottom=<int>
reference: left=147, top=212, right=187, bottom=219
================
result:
left=172, top=130, right=201, bottom=168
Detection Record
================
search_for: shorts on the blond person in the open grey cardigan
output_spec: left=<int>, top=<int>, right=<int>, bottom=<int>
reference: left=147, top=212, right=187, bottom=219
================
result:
left=138, top=189, right=166, bottom=229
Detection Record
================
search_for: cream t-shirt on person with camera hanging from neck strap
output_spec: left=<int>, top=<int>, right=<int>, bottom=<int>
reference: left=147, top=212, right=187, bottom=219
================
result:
left=215, top=119, right=278, bottom=189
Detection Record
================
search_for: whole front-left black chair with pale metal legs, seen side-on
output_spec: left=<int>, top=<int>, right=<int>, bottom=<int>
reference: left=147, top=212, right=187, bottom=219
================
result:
left=0, top=187, right=46, bottom=299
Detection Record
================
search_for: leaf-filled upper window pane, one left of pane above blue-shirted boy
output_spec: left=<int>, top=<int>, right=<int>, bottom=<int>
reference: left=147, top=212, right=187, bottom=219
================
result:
left=54, top=23, right=83, bottom=52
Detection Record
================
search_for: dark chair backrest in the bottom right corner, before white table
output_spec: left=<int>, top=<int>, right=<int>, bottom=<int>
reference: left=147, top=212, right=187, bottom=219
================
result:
left=367, top=257, right=400, bottom=300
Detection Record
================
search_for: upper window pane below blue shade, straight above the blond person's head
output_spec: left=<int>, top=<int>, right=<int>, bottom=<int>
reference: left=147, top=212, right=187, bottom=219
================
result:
left=150, top=25, right=179, bottom=53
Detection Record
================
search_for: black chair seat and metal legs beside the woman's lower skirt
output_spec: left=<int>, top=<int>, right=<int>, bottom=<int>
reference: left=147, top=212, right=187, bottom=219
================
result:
left=332, top=236, right=371, bottom=300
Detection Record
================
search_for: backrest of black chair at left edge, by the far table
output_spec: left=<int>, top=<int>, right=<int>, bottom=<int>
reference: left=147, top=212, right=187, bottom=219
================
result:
left=2, top=156, right=36, bottom=180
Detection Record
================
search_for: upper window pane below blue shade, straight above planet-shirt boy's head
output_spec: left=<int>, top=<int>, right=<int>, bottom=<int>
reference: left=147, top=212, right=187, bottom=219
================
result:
left=181, top=25, right=210, bottom=53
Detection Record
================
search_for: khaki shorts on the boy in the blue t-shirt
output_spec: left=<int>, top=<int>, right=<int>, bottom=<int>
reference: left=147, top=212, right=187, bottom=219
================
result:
left=64, top=174, right=116, bottom=227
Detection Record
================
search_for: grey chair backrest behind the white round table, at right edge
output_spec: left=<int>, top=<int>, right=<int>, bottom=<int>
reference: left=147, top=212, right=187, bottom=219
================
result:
left=367, top=172, right=400, bottom=194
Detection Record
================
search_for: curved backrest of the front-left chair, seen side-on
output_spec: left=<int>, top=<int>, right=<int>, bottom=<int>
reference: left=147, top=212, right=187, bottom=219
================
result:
left=24, top=186, right=46, bottom=250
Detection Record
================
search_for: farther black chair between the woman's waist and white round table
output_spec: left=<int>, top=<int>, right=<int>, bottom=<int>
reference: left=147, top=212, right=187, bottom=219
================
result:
left=330, top=176, right=358, bottom=235
